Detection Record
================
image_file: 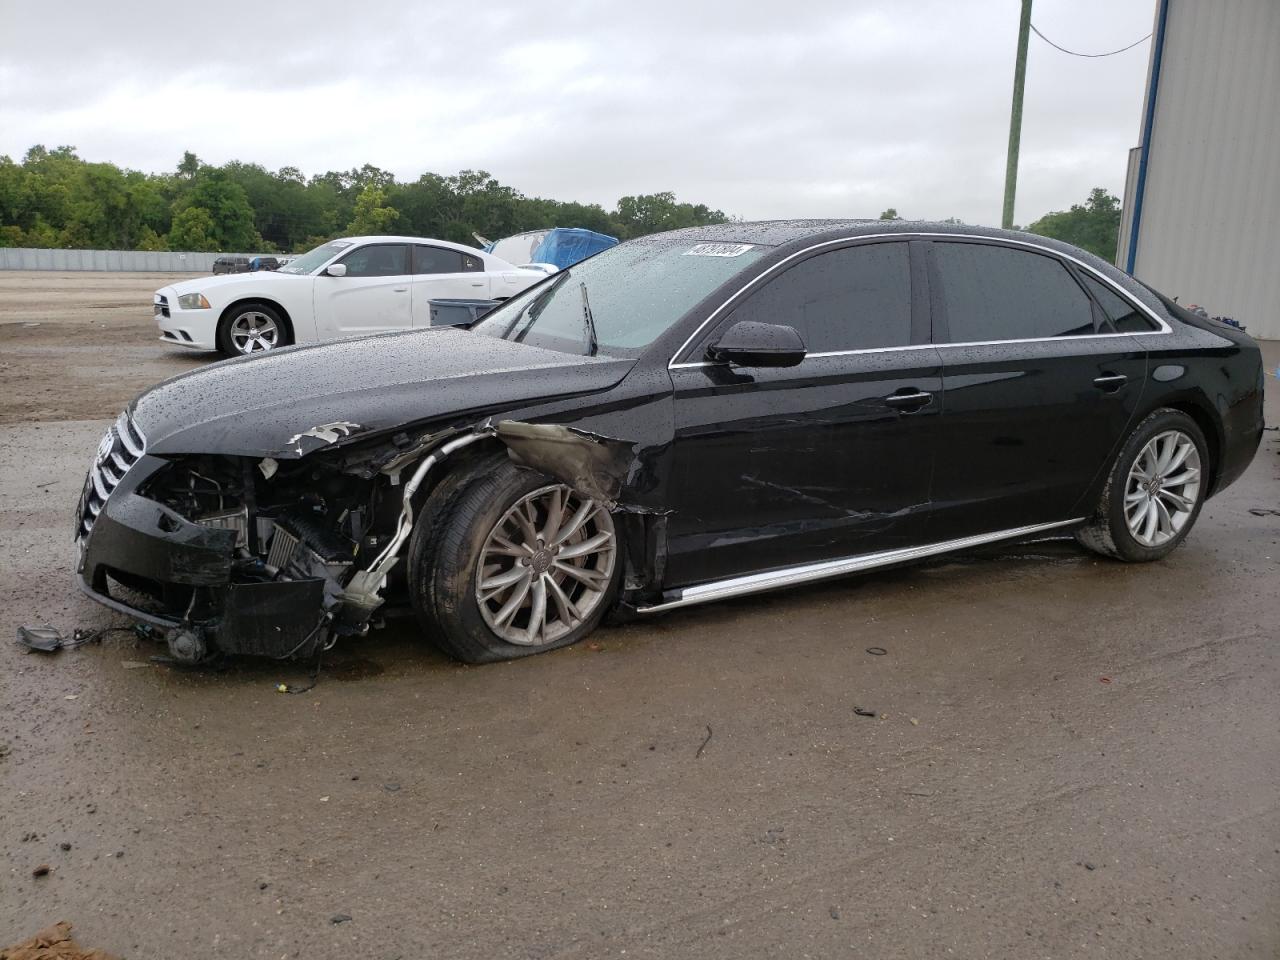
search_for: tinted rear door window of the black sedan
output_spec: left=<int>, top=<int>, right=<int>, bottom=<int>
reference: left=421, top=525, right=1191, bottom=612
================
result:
left=933, top=242, right=1097, bottom=343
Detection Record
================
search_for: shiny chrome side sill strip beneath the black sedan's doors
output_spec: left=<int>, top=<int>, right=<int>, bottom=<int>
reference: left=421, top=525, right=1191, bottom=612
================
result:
left=636, top=517, right=1085, bottom=613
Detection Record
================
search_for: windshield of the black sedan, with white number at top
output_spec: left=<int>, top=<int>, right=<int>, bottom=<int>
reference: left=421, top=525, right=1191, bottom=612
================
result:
left=471, top=239, right=764, bottom=357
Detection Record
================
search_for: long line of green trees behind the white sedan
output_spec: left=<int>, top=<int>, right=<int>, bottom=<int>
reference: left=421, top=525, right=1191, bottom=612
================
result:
left=0, top=143, right=727, bottom=251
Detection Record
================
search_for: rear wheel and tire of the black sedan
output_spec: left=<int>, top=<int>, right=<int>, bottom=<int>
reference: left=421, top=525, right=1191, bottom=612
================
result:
left=1075, top=407, right=1210, bottom=563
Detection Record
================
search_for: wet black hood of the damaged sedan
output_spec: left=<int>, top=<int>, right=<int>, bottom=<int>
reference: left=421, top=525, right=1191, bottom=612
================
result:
left=129, top=328, right=635, bottom=458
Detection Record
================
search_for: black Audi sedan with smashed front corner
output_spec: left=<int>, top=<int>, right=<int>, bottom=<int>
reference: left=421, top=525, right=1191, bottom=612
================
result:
left=76, top=220, right=1262, bottom=662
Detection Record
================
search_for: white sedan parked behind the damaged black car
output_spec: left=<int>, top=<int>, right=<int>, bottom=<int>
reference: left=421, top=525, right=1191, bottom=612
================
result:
left=154, top=237, right=547, bottom=356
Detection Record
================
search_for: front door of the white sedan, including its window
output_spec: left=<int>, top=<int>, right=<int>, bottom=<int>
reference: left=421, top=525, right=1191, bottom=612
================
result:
left=314, top=243, right=412, bottom=339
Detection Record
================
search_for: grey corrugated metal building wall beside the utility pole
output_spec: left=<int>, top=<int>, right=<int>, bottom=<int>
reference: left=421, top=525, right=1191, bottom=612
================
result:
left=1116, top=0, right=1280, bottom=339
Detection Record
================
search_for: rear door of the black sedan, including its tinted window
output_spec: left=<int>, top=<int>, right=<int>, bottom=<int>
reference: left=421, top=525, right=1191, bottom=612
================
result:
left=929, top=239, right=1147, bottom=540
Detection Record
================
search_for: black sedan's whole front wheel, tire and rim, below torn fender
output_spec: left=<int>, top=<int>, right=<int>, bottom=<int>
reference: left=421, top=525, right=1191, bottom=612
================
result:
left=408, top=458, right=622, bottom=663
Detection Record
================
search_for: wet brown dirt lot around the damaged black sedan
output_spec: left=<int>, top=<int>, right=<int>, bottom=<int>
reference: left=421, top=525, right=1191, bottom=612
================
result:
left=0, top=273, right=1280, bottom=960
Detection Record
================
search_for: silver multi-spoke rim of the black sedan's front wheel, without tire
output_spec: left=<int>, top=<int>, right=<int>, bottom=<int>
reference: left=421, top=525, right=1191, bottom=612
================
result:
left=475, top=484, right=618, bottom=646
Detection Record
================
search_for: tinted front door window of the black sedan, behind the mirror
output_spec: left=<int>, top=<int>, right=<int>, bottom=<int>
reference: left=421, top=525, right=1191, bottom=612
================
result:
left=722, top=243, right=911, bottom=353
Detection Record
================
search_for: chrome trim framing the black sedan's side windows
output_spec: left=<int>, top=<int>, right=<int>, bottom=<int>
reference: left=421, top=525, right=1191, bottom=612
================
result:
left=667, top=233, right=1172, bottom=370
